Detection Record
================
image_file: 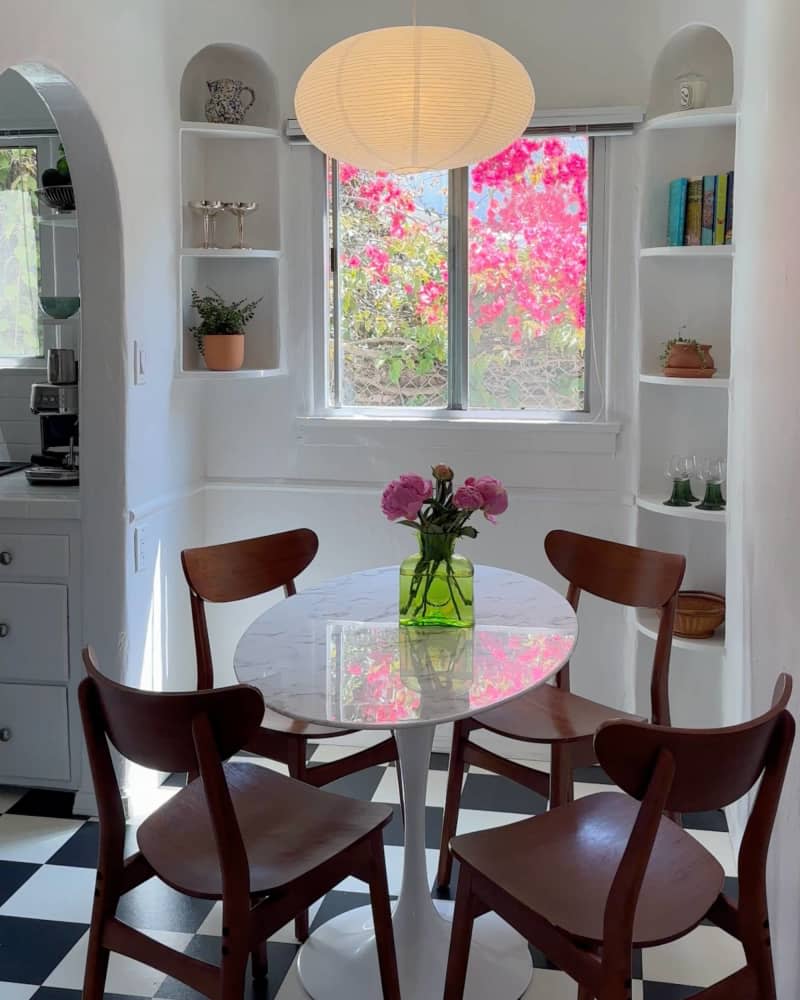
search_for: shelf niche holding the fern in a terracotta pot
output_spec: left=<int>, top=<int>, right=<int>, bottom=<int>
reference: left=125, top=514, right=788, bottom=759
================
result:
left=179, top=256, right=281, bottom=376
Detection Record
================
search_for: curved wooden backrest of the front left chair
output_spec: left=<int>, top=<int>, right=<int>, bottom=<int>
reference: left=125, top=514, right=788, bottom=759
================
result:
left=81, top=648, right=264, bottom=772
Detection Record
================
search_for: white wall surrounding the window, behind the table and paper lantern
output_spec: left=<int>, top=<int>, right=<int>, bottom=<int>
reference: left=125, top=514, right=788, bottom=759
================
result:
left=207, top=0, right=684, bottom=707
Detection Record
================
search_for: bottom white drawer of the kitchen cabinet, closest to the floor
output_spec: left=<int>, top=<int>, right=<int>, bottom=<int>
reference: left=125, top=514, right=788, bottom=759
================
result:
left=0, top=684, right=70, bottom=781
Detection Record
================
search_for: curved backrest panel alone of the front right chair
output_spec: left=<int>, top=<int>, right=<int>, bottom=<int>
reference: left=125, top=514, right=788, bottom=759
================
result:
left=595, top=674, right=792, bottom=813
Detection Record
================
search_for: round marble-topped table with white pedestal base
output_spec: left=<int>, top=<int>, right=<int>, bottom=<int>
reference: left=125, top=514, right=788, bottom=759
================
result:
left=234, top=566, right=577, bottom=1000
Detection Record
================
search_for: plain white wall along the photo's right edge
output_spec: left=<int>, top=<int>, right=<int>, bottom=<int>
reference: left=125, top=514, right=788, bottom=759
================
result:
left=727, top=0, right=800, bottom=1000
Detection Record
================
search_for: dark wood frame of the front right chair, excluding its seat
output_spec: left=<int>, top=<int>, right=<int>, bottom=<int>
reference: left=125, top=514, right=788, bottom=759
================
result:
left=444, top=674, right=795, bottom=1000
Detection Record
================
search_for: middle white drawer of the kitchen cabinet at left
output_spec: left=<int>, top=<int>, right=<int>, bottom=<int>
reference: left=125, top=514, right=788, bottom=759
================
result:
left=0, top=583, right=69, bottom=682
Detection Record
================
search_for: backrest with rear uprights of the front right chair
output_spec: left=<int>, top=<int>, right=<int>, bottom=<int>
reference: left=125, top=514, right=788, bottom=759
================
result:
left=595, top=674, right=795, bottom=984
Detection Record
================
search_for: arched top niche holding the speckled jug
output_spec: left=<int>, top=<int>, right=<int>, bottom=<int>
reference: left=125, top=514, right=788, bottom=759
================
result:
left=181, top=43, right=280, bottom=128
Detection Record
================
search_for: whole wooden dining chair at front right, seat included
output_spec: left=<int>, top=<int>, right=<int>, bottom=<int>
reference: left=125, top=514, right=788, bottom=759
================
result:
left=444, top=674, right=795, bottom=1000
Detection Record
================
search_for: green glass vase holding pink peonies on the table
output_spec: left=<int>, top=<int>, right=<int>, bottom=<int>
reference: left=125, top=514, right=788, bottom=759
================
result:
left=400, top=531, right=475, bottom=628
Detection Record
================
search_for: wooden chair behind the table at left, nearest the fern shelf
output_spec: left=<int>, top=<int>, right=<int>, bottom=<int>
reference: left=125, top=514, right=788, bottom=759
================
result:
left=181, top=528, right=402, bottom=941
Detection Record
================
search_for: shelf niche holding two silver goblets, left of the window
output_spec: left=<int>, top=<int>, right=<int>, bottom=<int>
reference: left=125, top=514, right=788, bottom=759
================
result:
left=181, top=129, right=280, bottom=251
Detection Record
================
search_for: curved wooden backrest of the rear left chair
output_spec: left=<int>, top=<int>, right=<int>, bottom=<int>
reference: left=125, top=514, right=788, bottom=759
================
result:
left=181, top=528, right=319, bottom=691
